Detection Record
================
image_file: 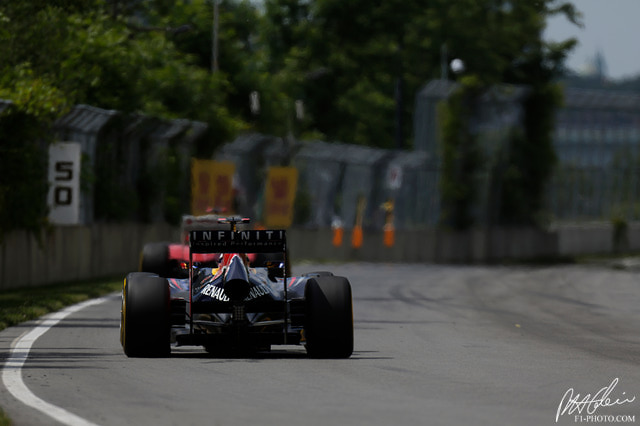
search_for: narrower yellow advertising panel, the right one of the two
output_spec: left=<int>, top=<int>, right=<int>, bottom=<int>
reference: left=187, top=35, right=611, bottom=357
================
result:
left=264, top=167, right=298, bottom=228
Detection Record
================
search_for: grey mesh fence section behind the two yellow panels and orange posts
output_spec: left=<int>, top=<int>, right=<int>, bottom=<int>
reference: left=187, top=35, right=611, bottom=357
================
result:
left=216, top=135, right=437, bottom=228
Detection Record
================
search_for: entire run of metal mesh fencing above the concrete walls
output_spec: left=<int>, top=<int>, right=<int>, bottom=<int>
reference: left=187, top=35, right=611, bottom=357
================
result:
left=41, top=80, right=640, bottom=229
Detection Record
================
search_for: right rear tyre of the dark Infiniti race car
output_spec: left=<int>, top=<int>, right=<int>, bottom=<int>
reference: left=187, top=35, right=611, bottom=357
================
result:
left=304, top=276, right=353, bottom=358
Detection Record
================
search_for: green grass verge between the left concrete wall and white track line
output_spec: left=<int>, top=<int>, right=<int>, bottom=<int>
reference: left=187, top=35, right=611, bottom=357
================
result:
left=0, top=278, right=122, bottom=426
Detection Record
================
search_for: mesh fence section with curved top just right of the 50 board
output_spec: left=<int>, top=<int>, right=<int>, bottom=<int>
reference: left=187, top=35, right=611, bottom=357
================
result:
left=54, top=105, right=208, bottom=223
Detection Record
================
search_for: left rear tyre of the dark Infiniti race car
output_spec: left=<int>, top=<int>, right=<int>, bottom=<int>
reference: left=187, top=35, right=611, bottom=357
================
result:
left=120, top=272, right=171, bottom=357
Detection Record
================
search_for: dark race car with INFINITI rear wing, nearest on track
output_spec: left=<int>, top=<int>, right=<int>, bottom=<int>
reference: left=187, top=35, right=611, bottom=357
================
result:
left=120, top=218, right=353, bottom=358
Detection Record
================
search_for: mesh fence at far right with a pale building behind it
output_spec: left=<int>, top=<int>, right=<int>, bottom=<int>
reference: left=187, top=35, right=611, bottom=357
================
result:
left=548, top=89, right=640, bottom=221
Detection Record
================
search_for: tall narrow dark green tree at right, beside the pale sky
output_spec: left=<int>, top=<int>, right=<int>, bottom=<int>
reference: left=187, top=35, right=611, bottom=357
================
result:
left=497, top=0, right=582, bottom=225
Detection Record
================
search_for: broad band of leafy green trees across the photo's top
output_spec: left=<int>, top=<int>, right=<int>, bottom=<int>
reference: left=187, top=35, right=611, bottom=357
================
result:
left=0, top=0, right=579, bottom=147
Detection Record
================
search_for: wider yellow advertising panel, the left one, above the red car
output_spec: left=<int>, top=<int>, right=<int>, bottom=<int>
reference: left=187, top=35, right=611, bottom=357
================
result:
left=191, top=158, right=236, bottom=215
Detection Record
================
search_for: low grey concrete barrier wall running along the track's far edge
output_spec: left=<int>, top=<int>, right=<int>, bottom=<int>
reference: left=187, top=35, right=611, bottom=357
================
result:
left=0, top=223, right=640, bottom=290
